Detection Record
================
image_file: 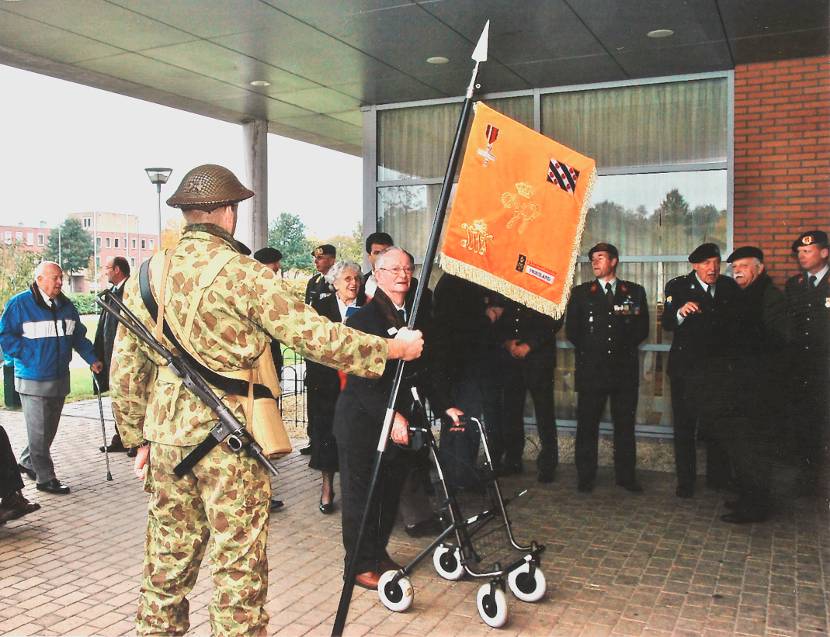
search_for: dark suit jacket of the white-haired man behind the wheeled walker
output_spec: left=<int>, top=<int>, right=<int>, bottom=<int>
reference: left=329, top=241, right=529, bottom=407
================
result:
left=334, top=290, right=423, bottom=457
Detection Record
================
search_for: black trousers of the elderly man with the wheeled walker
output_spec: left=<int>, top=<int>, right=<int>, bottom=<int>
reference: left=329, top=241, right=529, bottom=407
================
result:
left=337, top=441, right=410, bottom=573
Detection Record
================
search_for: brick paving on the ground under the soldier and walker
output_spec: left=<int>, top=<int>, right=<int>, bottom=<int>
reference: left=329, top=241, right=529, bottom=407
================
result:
left=0, top=401, right=830, bottom=637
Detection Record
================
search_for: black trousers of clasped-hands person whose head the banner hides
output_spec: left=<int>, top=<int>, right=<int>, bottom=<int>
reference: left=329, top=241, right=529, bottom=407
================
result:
left=500, top=356, right=559, bottom=469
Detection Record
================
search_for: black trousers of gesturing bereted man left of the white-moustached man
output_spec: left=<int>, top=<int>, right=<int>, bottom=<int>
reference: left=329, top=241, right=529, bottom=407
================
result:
left=671, top=376, right=732, bottom=489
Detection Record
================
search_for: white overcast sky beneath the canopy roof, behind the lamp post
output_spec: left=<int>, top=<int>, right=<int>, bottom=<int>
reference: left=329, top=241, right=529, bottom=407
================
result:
left=0, top=65, right=362, bottom=238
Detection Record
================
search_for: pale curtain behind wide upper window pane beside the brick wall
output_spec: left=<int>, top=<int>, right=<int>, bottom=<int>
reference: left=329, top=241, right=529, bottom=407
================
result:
left=541, top=78, right=728, bottom=168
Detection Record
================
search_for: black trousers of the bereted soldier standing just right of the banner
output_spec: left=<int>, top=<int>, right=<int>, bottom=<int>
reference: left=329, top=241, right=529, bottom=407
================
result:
left=575, top=385, right=638, bottom=484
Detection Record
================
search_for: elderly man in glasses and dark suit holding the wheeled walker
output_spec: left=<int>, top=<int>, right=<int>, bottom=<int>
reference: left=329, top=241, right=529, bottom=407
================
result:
left=334, top=247, right=428, bottom=589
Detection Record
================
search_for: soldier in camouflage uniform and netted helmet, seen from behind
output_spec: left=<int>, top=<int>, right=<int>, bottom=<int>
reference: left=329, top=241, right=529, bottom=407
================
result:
left=111, top=165, right=423, bottom=635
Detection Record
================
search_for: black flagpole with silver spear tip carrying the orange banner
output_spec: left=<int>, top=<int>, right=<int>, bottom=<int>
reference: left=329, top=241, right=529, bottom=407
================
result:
left=331, top=20, right=490, bottom=637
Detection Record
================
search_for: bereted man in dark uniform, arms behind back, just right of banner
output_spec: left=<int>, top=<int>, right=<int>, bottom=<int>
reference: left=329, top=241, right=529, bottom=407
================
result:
left=565, top=243, right=649, bottom=493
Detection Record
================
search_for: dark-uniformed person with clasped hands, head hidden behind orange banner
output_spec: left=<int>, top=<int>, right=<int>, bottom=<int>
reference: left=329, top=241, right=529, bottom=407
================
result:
left=490, top=301, right=562, bottom=483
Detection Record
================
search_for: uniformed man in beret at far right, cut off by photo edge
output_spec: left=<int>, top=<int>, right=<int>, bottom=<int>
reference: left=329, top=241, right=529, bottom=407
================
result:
left=784, top=230, right=830, bottom=498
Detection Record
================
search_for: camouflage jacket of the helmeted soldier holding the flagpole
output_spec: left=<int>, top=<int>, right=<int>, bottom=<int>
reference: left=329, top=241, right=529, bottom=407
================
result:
left=110, top=225, right=387, bottom=447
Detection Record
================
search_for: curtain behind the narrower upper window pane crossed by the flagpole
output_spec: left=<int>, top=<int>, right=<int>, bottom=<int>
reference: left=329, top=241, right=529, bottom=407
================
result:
left=378, top=96, right=533, bottom=181
